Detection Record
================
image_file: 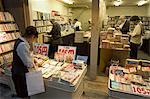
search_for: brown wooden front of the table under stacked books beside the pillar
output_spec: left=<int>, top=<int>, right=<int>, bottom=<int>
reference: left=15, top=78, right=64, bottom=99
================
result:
left=99, top=47, right=130, bottom=71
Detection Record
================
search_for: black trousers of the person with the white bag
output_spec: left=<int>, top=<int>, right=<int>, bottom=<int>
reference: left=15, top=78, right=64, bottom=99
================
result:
left=12, top=74, right=28, bottom=98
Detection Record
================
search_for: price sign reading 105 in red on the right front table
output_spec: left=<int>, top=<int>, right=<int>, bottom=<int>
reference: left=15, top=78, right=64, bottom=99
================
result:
left=132, top=85, right=150, bottom=96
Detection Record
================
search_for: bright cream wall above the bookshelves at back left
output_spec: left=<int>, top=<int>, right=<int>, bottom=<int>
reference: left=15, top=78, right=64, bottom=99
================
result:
left=29, top=0, right=69, bottom=25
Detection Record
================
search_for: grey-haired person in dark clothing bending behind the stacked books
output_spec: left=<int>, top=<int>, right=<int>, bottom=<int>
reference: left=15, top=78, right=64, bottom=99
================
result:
left=116, top=16, right=130, bottom=34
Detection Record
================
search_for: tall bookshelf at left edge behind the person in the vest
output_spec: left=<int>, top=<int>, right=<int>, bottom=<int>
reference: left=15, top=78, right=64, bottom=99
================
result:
left=0, top=12, right=20, bottom=73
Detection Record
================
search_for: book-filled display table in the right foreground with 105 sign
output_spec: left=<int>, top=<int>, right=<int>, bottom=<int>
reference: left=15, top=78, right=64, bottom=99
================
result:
left=108, top=59, right=150, bottom=99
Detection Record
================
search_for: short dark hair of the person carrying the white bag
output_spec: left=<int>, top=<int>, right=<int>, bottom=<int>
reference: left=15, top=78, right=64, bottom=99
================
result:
left=23, top=26, right=38, bottom=37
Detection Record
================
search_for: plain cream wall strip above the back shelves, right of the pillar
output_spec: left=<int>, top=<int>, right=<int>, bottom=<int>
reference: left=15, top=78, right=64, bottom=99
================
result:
left=107, top=6, right=148, bottom=16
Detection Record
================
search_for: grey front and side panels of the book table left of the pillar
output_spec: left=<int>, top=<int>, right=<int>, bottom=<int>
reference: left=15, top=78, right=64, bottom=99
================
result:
left=31, top=67, right=87, bottom=99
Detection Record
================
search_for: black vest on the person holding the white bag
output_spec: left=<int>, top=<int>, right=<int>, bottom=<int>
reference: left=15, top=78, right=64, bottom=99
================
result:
left=12, top=39, right=28, bottom=75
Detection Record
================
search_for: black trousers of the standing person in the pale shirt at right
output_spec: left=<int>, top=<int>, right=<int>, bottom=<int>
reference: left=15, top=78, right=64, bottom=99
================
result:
left=130, top=42, right=140, bottom=59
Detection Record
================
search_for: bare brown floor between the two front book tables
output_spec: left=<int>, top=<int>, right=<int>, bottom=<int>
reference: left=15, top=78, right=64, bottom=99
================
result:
left=81, top=76, right=112, bottom=99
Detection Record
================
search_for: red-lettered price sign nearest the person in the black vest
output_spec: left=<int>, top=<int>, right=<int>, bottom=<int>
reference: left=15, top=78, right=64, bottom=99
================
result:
left=33, top=43, right=49, bottom=56
